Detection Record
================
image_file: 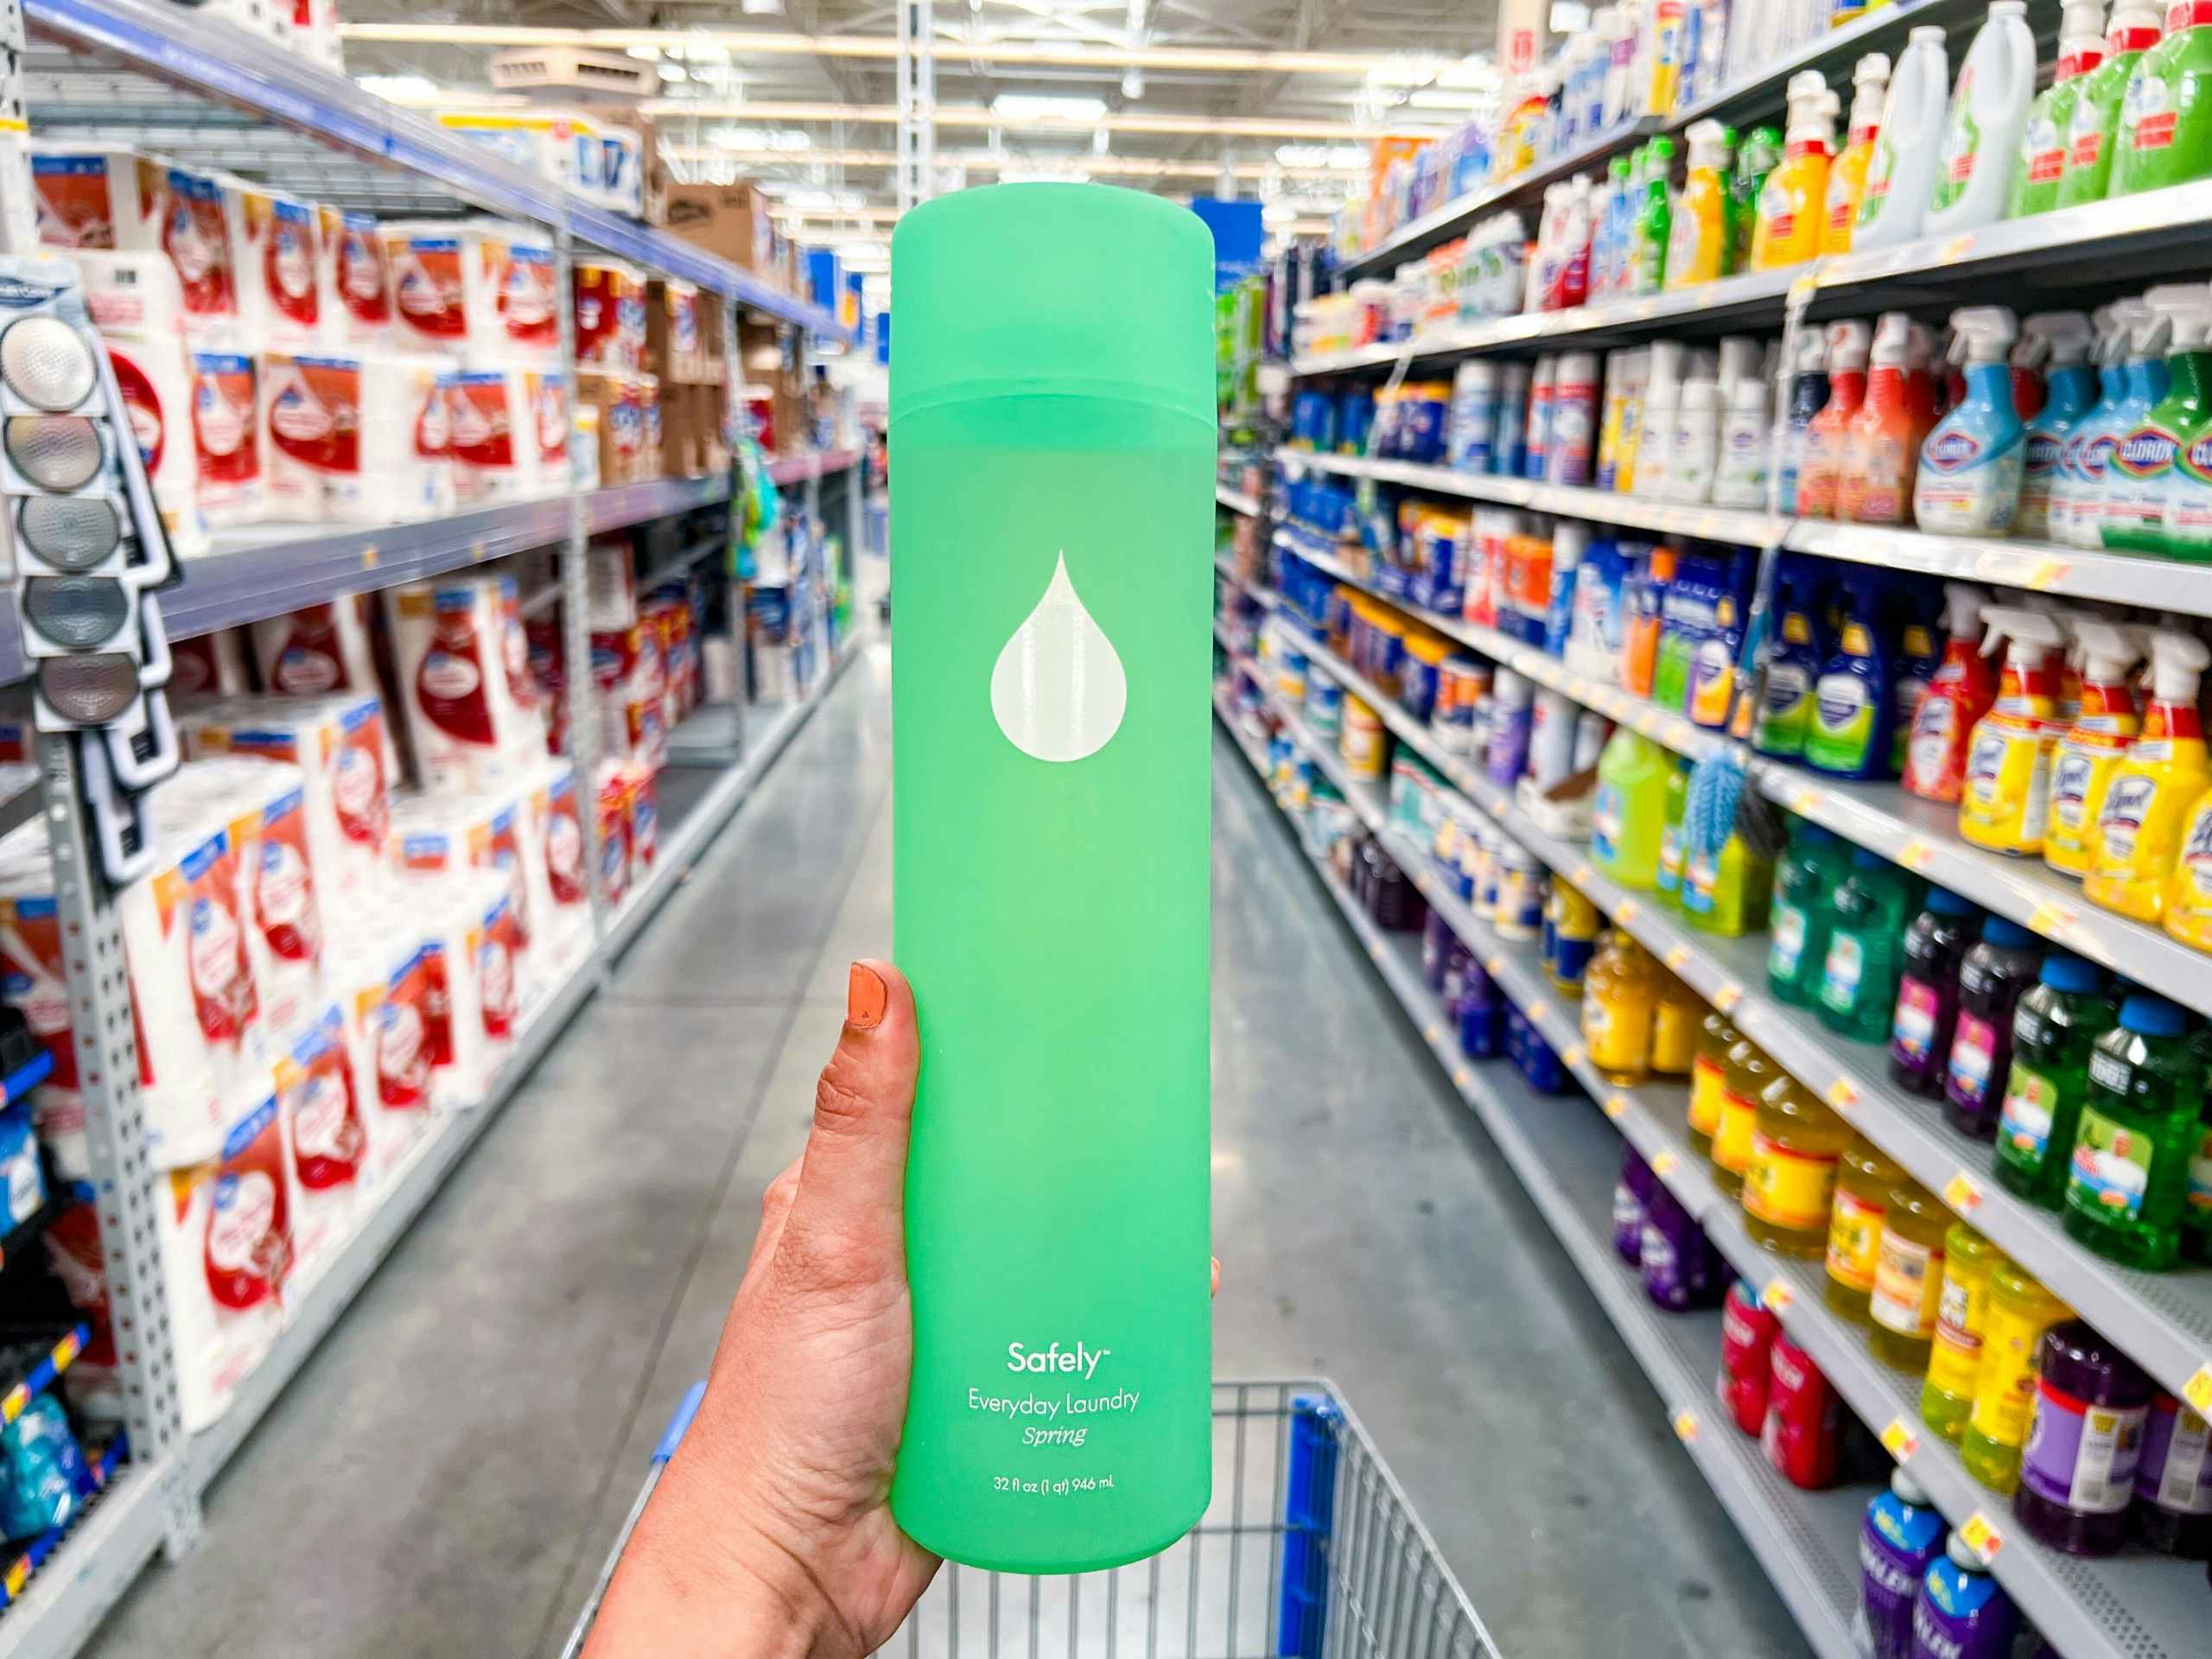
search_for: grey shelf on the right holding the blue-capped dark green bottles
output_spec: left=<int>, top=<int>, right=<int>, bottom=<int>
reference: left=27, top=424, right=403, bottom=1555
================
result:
left=1274, top=610, right=2212, bottom=1411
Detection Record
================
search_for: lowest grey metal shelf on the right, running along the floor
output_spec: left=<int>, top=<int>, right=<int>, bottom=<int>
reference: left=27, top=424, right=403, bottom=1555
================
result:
left=1214, top=699, right=1872, bottom=1659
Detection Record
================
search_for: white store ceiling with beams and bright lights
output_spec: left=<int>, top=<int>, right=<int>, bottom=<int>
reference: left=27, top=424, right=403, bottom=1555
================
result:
left=345, top=0, right=1497, bottom=256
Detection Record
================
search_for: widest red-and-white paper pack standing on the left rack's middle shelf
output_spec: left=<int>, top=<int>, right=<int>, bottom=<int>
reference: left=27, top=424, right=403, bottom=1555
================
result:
left=261, top=352, right=455, bottom=524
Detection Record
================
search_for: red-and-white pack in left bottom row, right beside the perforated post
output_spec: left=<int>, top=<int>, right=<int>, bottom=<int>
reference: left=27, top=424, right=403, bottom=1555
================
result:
left=155, top=1086, right=292, bottom=1433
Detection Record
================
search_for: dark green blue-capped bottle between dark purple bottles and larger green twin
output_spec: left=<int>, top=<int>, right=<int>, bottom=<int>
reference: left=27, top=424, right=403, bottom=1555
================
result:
left=1995, top=951, right=2119, bottom=1210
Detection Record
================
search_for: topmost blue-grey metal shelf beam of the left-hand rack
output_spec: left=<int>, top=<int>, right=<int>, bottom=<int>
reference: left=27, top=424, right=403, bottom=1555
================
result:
left=24, top=0, right=849, bottom=340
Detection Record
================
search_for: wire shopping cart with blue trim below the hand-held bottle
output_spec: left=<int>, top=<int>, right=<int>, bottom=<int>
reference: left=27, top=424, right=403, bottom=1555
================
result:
left=562, top=1380, right=1497, bottom=1659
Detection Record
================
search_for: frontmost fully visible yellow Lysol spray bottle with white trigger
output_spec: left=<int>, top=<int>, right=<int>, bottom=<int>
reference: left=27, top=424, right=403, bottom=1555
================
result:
left=2082, top=628, right=2212, bottom=923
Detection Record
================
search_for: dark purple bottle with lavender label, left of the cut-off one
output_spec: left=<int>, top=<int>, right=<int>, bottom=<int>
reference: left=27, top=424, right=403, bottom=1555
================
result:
left=2013, top=1319, right=2154, bottom=1555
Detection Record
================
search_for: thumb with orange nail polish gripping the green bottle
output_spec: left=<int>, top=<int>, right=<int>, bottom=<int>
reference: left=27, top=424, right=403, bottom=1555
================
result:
left=777, top=963, right=920, bottom=1285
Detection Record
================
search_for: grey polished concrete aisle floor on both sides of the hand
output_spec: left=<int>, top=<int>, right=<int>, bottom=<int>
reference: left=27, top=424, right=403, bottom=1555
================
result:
left=91, top=651, right=1794, bottom=1659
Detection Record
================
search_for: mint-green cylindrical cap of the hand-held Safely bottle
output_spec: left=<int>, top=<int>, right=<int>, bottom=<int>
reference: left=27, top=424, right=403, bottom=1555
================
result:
left=892, top=183, right=1217, bottom=429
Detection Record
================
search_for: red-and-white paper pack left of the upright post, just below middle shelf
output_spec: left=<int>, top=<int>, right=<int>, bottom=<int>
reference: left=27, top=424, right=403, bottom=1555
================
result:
left=390, top=577, right=544, bottom=794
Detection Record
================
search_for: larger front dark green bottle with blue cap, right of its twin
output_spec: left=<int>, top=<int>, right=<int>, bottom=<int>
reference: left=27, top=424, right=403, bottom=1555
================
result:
left=2066, top=993, right=2205, bottom=1269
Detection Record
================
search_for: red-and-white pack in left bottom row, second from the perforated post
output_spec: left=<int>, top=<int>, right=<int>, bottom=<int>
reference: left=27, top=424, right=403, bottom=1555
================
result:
left=274, top=1000, right=370, bottom=1312
